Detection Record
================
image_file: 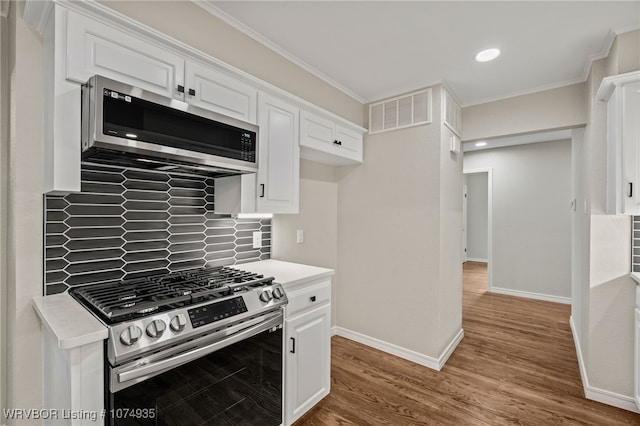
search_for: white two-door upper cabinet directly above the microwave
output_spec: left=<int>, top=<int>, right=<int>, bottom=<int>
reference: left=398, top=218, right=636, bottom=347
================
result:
left=66, top=11, right=258, bottom=124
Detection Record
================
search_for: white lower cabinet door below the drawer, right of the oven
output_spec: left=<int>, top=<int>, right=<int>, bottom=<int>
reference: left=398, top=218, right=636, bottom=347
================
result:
left=285, top=305, right=331, bottom=425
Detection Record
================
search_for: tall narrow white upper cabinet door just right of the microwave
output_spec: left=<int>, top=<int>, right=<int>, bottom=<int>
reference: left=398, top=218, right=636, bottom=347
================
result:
left=257, top=93, right=300, bottom=213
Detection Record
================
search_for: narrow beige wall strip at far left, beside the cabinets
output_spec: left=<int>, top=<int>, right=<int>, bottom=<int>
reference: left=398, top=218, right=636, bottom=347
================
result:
left=6, top=2, right=43, bottom=420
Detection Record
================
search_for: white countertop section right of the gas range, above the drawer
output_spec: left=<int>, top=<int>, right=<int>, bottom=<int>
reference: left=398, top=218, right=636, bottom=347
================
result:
left=232, top=259, right=334, bottom=289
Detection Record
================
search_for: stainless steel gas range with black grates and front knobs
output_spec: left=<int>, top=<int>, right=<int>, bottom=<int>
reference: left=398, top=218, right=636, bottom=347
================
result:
left=69, top=267, right=288, bottom=426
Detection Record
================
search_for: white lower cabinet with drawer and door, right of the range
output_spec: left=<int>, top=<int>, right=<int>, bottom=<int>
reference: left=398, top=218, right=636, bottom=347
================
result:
left=285, top=281, right=331, bottom=425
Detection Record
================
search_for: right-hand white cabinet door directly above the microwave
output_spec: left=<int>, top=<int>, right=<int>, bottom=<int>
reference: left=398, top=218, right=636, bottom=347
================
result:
left=185, top=62, right=258, bottom=124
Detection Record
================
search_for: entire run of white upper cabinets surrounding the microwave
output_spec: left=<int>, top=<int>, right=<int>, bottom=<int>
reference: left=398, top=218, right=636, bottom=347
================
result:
left=35, top=2, right=365, bottom=196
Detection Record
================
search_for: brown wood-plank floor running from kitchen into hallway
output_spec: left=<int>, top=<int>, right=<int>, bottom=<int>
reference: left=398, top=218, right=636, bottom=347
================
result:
left=295, top=262, right=640, bottom=426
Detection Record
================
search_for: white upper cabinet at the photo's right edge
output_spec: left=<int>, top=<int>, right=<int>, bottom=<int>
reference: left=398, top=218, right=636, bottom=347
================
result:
left=596, top=71, right=640, bottom=215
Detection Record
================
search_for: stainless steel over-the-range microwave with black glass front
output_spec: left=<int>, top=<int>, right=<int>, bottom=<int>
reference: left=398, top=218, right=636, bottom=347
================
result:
left=82, top=76, right=258, bottom=176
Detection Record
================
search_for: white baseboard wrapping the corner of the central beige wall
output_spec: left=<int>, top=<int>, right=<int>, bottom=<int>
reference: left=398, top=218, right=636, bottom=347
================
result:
left=332, top=327, right=464, bottom=371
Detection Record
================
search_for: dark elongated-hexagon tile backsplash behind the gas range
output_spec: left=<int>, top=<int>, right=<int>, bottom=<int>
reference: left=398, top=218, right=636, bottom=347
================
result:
left=44, top=163, right=271, bottom=295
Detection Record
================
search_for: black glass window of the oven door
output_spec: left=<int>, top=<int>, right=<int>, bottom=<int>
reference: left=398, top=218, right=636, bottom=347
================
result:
left=108, top=327, right=283, bottom=426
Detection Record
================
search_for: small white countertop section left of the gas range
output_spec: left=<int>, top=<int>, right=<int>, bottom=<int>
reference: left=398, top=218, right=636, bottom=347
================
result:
left=33, top=293, right=108, bottom=349
